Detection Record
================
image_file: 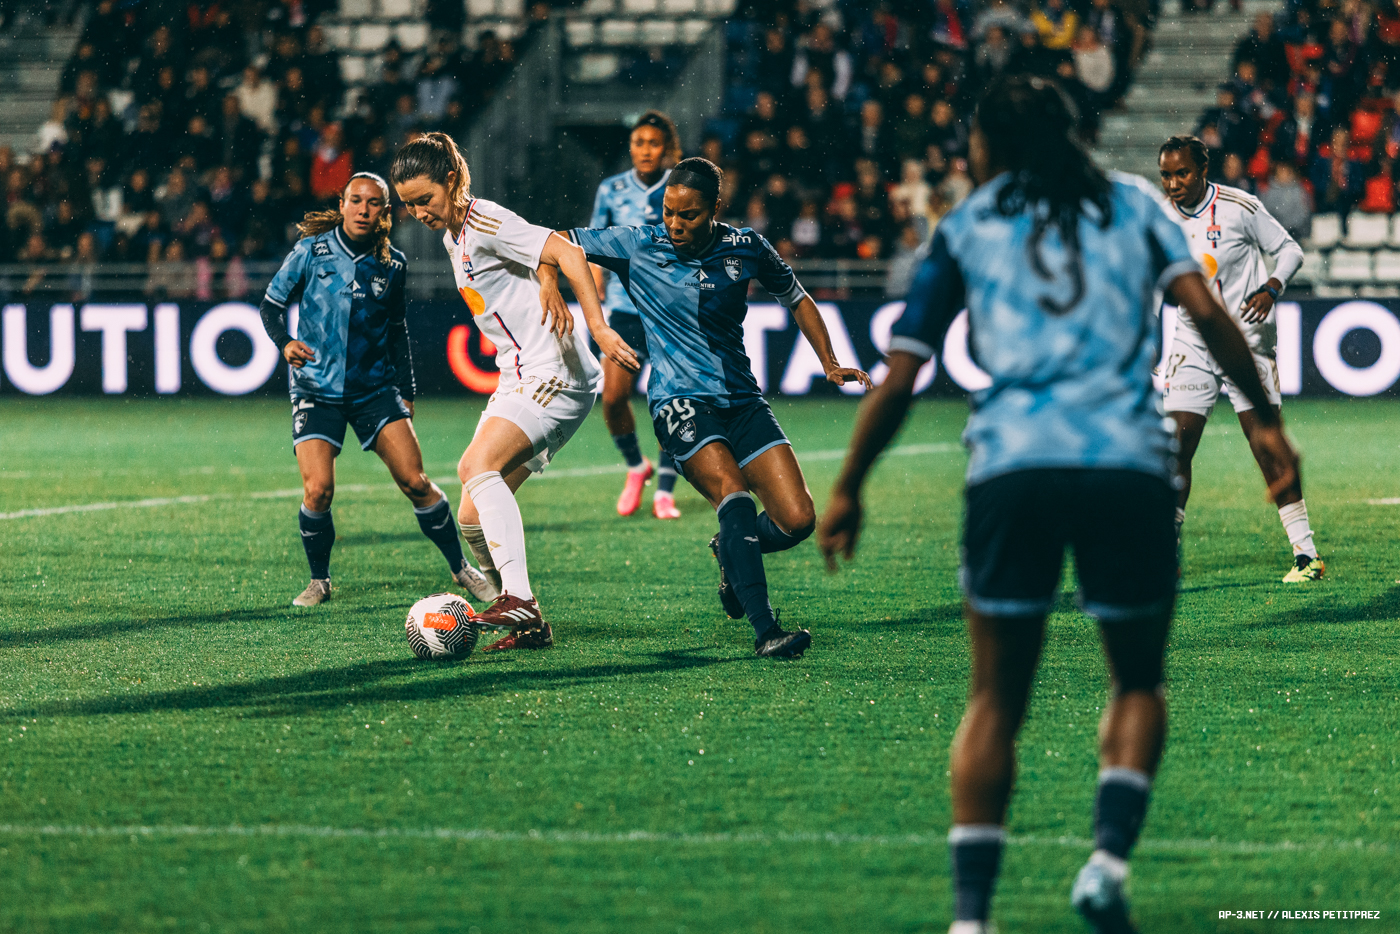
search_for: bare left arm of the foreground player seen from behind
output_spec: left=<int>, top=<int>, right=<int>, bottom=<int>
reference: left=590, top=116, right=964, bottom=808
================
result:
left=816, top=350, right=925, bottom=571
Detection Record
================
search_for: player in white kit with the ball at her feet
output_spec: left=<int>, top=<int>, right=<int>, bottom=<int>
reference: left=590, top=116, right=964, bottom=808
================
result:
left=389, top=133, right=637, bottom=651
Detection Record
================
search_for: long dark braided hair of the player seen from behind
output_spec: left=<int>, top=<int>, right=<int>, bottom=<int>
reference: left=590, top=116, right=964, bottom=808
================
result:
left=974, top=77, right=1113, bottom=315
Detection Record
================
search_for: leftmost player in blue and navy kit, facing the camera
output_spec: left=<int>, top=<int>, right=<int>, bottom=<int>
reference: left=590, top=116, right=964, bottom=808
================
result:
left=260, top=172, right=490, bottom=606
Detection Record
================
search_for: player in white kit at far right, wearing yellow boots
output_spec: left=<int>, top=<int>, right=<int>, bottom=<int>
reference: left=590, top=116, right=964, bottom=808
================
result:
left=1158, top=136, right=1326, bottom=584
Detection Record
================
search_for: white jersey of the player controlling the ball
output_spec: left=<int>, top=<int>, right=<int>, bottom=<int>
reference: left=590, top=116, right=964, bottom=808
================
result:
left=442, top=197, right=602, bottom=392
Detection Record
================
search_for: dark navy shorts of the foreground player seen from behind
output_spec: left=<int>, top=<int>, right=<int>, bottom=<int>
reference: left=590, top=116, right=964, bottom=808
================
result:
left=962, top=469, right=1177, bottom=623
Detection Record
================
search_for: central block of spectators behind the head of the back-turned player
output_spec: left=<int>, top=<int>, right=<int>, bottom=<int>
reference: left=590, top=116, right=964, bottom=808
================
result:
left=703, top=0, right=1156, bottom=291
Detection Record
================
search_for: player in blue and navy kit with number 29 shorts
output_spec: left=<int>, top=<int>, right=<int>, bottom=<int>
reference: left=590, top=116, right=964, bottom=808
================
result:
left=554, top=158, right=869, bottom=658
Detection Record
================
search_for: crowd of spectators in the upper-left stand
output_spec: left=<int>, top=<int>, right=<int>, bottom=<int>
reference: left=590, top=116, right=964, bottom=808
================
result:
left=0, top=0, right=549, bottom=297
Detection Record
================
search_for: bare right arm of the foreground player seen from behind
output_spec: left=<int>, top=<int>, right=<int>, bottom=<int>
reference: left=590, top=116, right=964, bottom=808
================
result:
left=1168, top=273, right=1298, bottom=500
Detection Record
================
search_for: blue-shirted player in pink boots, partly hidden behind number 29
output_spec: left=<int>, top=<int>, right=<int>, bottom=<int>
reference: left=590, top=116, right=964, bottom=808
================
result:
left=588, top=111, right=680, bottom=520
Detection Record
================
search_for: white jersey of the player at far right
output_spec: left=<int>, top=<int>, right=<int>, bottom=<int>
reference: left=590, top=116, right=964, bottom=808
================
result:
left=1172, top=182, right=1303, bottom=357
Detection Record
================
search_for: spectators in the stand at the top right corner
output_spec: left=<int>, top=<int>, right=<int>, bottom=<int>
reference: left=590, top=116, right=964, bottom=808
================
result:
left=1196, top=0, right=1400, bottom=243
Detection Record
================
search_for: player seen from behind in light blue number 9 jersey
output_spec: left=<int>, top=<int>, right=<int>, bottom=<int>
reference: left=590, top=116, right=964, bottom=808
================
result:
left=819, top=78, right=1298, bottom=934
